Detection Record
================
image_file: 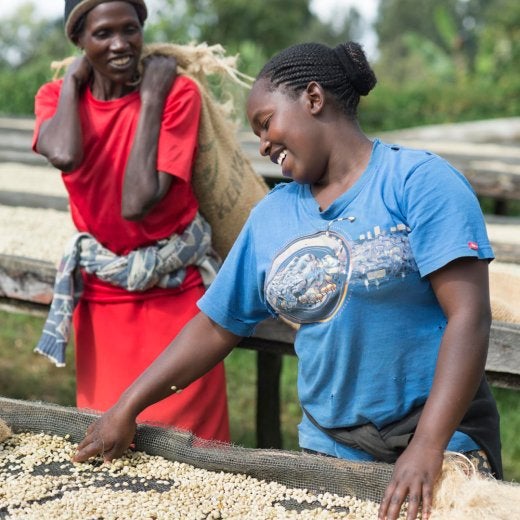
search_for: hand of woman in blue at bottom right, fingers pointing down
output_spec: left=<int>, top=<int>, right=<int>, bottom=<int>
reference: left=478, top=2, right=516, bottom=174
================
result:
left=378, top=439, right=444, bottom=520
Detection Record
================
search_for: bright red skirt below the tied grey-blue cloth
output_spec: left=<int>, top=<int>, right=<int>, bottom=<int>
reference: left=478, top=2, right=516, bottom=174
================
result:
left=74, top=286, right=230, bottom=442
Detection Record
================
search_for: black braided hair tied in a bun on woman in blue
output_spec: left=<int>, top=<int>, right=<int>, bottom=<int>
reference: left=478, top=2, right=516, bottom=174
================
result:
left=256, top=42, right=377, bottom=117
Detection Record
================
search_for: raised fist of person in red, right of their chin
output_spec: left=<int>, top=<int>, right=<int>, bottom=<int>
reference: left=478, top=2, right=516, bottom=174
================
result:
left=140, top=56, right=177, bottom=103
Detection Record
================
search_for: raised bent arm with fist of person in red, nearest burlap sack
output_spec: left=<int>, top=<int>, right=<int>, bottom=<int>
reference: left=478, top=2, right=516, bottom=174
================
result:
left=121, top=56, right=177, bottom=220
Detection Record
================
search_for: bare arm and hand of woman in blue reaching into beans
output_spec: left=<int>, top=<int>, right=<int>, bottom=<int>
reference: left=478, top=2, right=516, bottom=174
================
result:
left=74, top=313, right=241, bottom=462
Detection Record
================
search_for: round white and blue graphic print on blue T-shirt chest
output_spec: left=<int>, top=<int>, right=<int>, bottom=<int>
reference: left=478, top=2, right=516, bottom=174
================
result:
left=265, top=224, right=417, bottom=324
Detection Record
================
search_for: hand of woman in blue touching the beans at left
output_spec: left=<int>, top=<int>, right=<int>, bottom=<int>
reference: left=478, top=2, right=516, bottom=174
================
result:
left=72, top=405, right=136, bottom=462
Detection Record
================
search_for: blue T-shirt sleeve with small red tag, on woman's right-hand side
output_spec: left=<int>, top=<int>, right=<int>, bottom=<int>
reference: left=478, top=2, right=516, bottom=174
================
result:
left=403, top=155, right=494, bottom=276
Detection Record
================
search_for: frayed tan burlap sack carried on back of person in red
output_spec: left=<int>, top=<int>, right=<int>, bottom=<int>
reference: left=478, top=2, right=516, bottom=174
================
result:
left=52, top=43, right=269, bottom=258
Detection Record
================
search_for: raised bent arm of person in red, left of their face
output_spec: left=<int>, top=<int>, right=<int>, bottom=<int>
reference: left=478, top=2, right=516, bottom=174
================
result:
left=36, top=57, right=92, bottom=172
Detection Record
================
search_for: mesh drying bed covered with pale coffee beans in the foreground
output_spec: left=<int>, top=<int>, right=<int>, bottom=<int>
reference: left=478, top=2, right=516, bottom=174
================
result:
left=0, top=398, right=398, bottom=519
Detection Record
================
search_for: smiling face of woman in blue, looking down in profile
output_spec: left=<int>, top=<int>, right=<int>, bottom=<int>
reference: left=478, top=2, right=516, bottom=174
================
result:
left=247, top=79, right=328, bottom=184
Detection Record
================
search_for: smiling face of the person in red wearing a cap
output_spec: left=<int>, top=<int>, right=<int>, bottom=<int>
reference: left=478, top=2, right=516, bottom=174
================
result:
left=78, top=1, right=143, bottom=95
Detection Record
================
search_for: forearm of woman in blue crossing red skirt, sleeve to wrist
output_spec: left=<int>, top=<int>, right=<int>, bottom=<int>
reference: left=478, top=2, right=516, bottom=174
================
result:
left=117, top=313, right=241, bottom=418
